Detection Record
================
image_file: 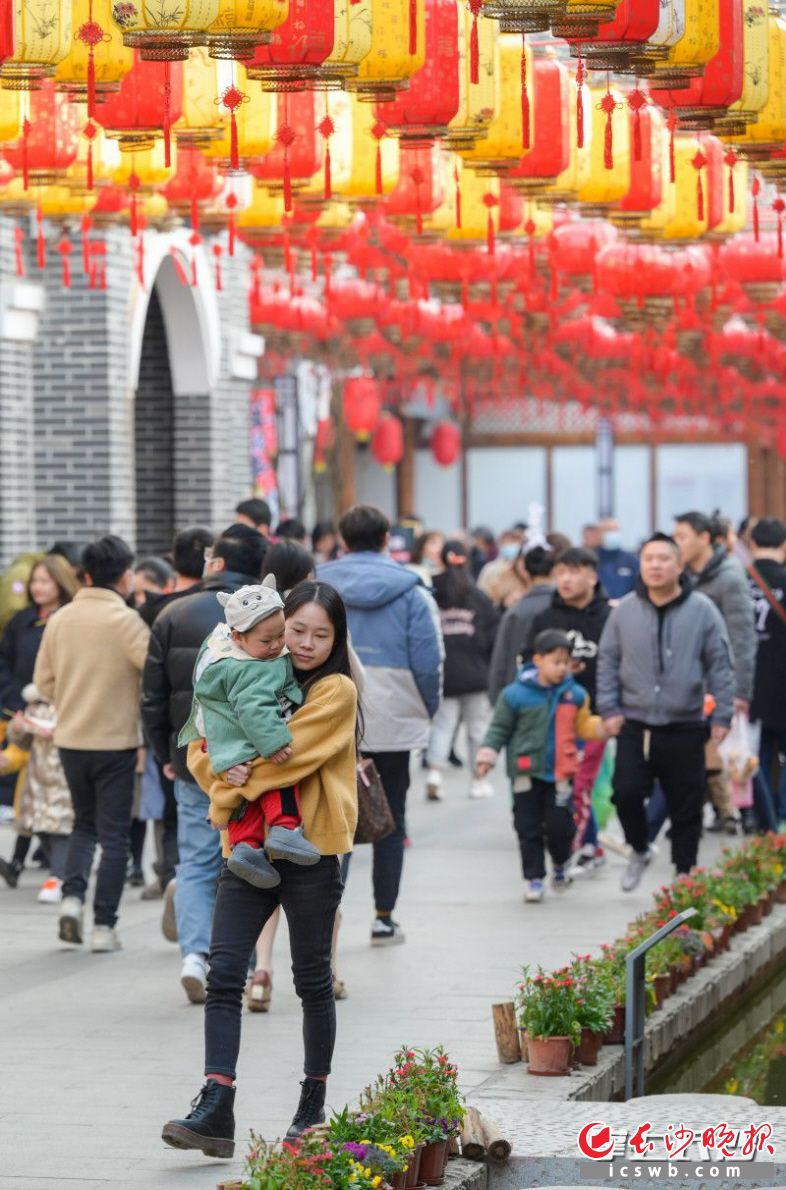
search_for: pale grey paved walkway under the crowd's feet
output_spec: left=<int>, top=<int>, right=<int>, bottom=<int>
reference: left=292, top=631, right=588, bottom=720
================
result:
left=0, top=756, right=717, bottom=1190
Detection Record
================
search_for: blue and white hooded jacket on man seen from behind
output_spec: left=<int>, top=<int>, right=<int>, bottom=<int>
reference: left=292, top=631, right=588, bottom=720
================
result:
left=316, top=550, right=445, bottom=752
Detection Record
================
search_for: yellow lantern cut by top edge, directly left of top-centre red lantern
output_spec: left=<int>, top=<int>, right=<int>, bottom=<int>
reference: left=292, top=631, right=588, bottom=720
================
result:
left=346, top=0, right=426, bottom=104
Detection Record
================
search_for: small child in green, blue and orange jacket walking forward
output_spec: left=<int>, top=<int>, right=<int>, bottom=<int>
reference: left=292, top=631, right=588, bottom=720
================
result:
left=476, top=628, right=608, bottom=902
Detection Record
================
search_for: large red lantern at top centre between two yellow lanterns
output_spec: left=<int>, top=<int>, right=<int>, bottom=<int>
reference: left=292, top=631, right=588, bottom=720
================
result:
left=377, top=0, right=459, bottom=143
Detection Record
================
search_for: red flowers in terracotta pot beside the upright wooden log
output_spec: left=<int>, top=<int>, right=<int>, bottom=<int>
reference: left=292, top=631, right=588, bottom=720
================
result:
left=517, top=967, right=581, bottom=1076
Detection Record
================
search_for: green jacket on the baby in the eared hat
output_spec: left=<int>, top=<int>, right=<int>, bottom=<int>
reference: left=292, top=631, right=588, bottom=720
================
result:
left=177, top=624, right=303, bottom=772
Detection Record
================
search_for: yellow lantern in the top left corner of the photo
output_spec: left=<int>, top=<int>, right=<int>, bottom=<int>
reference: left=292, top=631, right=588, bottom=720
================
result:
left=0, top=0, right=73, bottom=90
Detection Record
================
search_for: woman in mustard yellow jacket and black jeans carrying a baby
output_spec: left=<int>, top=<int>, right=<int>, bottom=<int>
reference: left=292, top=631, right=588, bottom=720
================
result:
left=162, top=581, right=358, bottom=1157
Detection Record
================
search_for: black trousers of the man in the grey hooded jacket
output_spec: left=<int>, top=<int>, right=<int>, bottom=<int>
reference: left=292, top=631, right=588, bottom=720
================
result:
left=612, top=720, right=708, bottom=873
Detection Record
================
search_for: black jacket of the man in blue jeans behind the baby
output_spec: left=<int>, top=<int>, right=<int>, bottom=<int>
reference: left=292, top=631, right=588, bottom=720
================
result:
left=142, top=570, right=259, bottom=783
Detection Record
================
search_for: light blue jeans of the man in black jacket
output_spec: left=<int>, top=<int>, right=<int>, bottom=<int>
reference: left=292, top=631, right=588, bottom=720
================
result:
left=175, top=781, right=221, bottom=954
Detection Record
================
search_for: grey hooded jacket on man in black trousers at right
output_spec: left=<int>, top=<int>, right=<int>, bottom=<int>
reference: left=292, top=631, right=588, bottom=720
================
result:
left=596, top=576, right=734, bottom=727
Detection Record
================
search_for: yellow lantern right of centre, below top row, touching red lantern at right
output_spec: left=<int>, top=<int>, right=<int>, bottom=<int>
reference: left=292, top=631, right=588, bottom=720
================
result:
left=461, top=33, right=534, bottom=173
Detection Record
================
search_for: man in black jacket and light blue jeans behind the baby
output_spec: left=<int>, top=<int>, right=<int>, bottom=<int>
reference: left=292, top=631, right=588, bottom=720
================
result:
left=142, top=525, right=268, bottom=1004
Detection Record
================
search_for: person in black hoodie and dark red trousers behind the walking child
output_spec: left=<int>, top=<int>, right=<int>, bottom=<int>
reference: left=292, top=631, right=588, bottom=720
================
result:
left=527, top=546, right=609, bottom=872
